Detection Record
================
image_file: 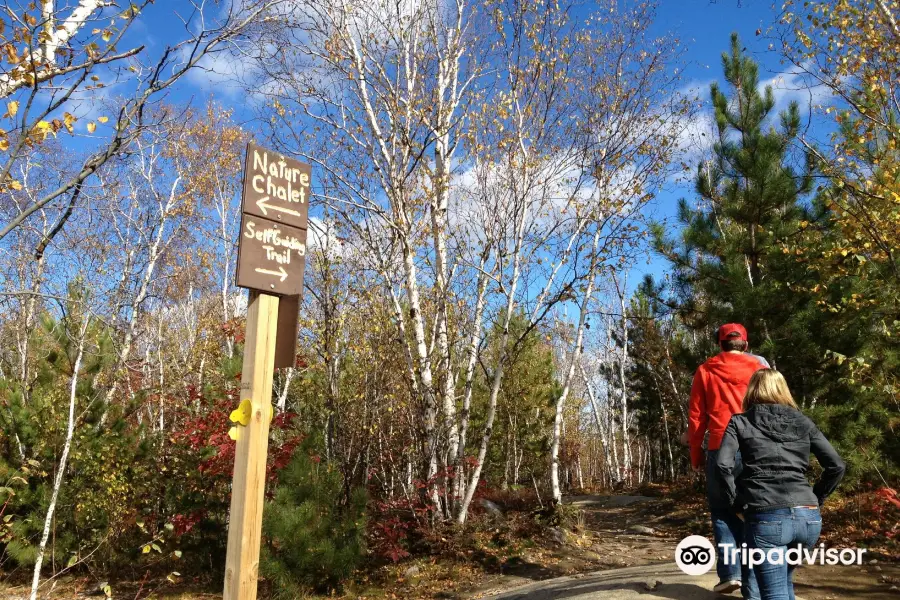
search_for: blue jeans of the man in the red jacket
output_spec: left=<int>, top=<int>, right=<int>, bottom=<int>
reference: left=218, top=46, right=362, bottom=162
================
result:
left=706, top=450, right=760, bottom=600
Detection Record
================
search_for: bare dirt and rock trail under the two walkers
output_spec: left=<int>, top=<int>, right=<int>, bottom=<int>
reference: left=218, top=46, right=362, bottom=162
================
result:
left=466, top=496, right=900, bottom=600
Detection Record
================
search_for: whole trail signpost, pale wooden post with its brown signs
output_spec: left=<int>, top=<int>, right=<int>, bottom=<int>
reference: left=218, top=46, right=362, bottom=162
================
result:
left=223, top=144, right=311, bottom=600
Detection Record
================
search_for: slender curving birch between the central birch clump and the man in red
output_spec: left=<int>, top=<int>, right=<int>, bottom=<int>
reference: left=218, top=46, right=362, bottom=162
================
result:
left=550, top=4, right=689, bottom=503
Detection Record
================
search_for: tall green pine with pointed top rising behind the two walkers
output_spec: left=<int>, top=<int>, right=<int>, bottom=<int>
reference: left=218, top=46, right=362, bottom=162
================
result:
left=656, top=34, right=855, bottom=405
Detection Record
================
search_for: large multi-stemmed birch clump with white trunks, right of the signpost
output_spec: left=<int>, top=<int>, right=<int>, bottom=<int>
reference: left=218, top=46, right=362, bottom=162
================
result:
left=248, top=1, right=692, bottom=521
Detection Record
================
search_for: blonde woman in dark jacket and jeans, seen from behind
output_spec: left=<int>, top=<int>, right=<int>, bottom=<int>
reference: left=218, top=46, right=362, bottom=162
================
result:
left=716, top=369, right=844, bottom=600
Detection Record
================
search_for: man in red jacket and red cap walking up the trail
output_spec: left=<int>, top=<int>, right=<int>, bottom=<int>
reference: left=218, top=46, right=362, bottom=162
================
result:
left=688, top=323, right=769, bottom=600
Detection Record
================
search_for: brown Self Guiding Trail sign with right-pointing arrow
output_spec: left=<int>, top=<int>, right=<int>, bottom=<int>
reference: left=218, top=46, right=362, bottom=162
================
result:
left=237, top=214, right=306, bottom=296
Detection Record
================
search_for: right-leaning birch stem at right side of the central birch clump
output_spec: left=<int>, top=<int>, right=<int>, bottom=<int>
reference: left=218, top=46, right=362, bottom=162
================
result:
left=455, top=2, right=585, bottom=523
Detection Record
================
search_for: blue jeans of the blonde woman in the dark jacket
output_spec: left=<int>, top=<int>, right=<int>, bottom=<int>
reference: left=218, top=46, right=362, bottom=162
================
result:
left=747, top=508, right=822, bottom=600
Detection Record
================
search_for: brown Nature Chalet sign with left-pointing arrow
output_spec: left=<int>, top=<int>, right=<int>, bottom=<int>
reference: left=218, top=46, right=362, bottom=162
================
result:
left=241, top=143, right=312, bottom=229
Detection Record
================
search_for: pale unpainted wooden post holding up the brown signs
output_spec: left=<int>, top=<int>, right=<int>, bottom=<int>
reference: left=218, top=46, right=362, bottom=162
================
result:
left=223, top=291, right=278, bottom=600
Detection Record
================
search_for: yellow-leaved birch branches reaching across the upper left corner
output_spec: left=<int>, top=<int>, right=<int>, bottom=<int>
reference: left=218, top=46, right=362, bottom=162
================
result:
left=0, top=0, right=281, bottom=245
